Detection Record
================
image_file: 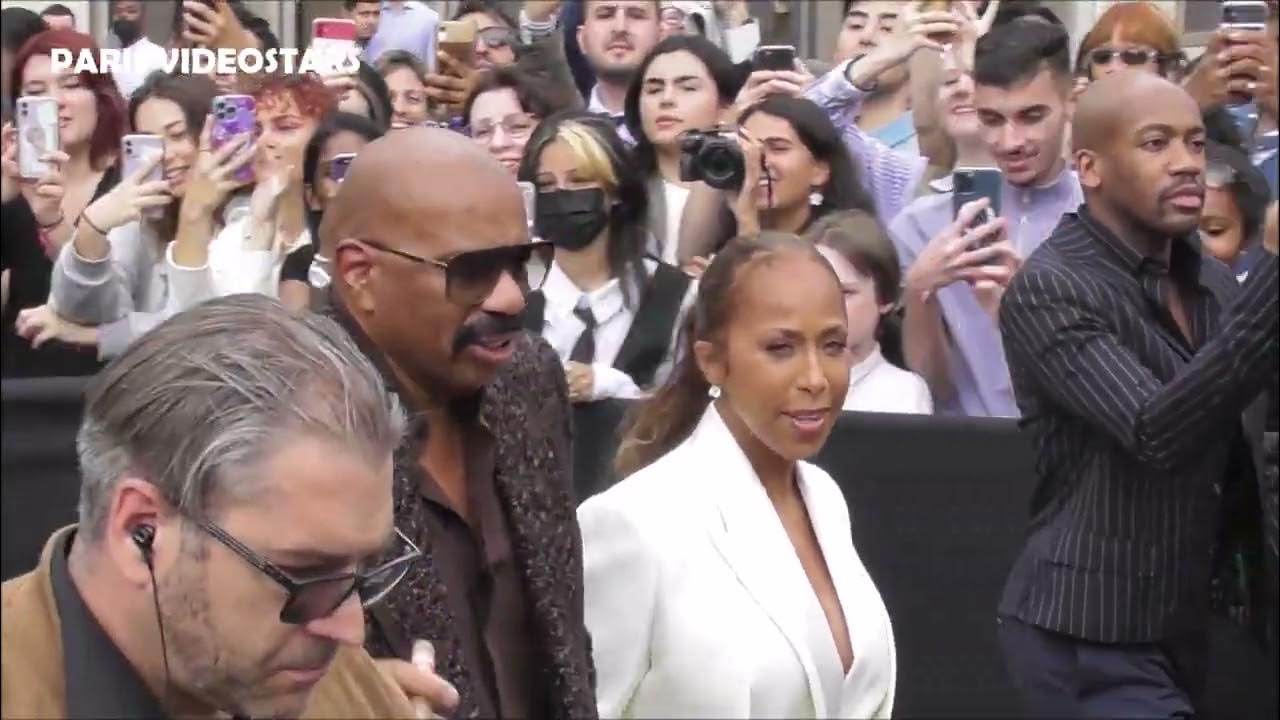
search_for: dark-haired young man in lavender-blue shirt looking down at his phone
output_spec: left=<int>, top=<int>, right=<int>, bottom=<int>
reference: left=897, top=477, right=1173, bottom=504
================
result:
left=890, top=19, right=1083, bottom=416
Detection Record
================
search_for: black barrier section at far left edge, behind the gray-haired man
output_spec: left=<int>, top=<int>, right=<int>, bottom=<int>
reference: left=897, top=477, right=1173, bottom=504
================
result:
left=0, top=378, right=87, bottom=580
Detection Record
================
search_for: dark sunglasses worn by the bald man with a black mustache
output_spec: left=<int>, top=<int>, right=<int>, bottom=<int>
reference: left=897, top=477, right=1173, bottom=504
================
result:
left=357, top=240, right=556, bottom=301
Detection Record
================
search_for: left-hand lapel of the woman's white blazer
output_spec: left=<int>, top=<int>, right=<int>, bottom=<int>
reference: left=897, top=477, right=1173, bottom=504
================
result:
left=690, top=405, right=828, bottom=717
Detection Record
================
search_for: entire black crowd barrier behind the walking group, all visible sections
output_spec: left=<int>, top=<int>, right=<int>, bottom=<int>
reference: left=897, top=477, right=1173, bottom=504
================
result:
left=0, top=378, right=1275, bottom=717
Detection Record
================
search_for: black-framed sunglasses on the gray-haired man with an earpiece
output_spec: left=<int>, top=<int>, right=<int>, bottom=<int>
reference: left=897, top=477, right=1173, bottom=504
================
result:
left=192, top=519, right=422, bottom=625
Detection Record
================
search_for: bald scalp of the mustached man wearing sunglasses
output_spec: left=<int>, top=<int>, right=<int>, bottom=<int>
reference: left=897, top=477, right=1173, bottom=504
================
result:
left=320, top=128, right=524, bottom=259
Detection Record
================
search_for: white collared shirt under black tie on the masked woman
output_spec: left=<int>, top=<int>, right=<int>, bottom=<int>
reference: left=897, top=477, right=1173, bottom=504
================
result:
left=543, top=260, right=694, bottom=400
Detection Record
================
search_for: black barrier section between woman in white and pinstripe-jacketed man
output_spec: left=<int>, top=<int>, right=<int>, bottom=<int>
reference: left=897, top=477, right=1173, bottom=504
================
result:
left=817, top=413, right=1033, bottom=717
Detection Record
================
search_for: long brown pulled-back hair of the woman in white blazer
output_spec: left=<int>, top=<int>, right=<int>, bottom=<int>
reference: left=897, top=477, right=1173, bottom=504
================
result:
left=614, top=232, right=827, bottom=478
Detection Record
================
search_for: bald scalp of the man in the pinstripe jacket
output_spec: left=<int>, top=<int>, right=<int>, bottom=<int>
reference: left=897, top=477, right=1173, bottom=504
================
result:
left=1071, top=70, right=1199, bottom=155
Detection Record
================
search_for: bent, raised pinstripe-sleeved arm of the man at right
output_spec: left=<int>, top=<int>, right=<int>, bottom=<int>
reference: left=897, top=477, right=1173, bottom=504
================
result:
left=1000, top=254, right=1280, bottom=470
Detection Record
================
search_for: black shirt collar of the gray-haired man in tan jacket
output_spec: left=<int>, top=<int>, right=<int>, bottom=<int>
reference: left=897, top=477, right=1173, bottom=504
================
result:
left=49, top=530, right=165, bottom=719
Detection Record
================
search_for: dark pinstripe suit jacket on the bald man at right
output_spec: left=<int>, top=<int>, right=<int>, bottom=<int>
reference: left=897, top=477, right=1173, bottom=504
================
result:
left=1000, top=206, right=1280, bottom=643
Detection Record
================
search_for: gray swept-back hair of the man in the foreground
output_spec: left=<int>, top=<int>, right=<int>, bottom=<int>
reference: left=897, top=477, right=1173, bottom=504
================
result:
left=76, top=295, right=404, bottom=542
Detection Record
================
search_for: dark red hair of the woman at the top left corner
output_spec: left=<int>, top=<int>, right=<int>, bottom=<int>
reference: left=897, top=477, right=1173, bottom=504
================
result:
left=10, top=29, right=128, bottom=170
